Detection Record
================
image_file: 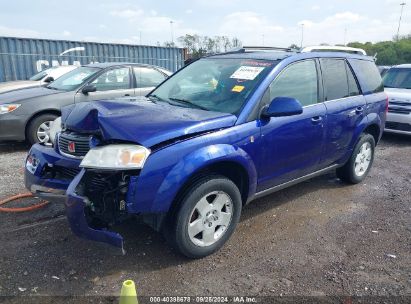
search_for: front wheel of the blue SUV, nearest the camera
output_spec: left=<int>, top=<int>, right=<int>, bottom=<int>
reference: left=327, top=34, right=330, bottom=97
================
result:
left=166, top=176, right=242, bottom=258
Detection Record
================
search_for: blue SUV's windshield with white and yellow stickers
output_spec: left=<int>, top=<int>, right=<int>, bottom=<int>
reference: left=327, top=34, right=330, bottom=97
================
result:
left=149, top=58, right=278, bottom=115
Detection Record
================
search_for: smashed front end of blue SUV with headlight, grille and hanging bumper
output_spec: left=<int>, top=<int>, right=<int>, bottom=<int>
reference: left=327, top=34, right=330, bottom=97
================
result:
left=25, top=104, right=154, bottom=250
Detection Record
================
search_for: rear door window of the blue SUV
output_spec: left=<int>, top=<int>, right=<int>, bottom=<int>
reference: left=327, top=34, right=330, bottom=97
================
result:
left=320, top=58, right=349, bottom=101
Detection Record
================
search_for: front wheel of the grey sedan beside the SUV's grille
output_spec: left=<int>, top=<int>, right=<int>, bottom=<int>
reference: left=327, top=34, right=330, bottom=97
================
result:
left=27, top=114, right=58, bottom=145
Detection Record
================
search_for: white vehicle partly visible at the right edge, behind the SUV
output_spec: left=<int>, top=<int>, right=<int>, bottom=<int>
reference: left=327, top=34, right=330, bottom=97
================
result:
left=383, top=64, right=411, bottom=135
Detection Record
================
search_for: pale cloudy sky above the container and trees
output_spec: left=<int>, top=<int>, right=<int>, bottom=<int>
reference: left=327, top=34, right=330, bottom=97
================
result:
left=0, top=0, right=411, bottom=47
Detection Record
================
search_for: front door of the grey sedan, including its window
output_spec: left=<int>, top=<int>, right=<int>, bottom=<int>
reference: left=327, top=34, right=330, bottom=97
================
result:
left=75, top=67, right=134, bottom=102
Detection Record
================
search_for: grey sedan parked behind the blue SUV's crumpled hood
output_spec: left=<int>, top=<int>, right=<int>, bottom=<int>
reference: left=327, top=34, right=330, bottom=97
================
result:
left=0, top=63, right=171, bottom=144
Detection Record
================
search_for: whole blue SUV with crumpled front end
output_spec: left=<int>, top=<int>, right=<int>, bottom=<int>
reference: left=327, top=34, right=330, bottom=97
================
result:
left=25, top=48, right=387, bottom=258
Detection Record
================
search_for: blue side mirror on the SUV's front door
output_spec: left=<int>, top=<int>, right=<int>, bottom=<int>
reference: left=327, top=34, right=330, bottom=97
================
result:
left=261, top=97, right=303, bottom=117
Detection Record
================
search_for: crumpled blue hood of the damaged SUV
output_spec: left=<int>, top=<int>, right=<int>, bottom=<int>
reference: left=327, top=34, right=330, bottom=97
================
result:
left=62, top=97, right=237, bottom=147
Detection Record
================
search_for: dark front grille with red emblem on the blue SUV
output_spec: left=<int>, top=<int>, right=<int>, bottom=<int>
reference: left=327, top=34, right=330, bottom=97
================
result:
left=59, top=132, right=90, bottom=158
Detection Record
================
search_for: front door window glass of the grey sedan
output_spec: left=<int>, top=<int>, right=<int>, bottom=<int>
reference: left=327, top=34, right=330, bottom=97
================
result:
left=92, top=68, right=130, bottom=91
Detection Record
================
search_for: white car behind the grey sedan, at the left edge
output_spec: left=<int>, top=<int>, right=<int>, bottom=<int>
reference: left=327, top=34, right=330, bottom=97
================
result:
left=0, top=65, right=77, bottom=94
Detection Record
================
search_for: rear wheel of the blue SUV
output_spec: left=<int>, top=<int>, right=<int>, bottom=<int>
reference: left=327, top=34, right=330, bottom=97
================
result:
left=337, top=134, right=375, bottom=184
